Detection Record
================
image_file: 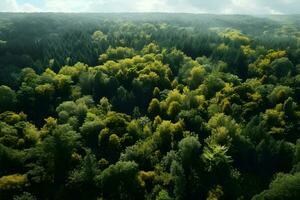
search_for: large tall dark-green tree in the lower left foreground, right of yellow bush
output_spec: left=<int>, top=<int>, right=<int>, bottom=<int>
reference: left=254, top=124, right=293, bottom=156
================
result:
left=28, top=124, right=79, bottom=196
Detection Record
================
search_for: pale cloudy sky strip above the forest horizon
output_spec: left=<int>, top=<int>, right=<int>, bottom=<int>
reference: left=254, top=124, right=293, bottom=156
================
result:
left=0, top=0, right=300, bottom=14
